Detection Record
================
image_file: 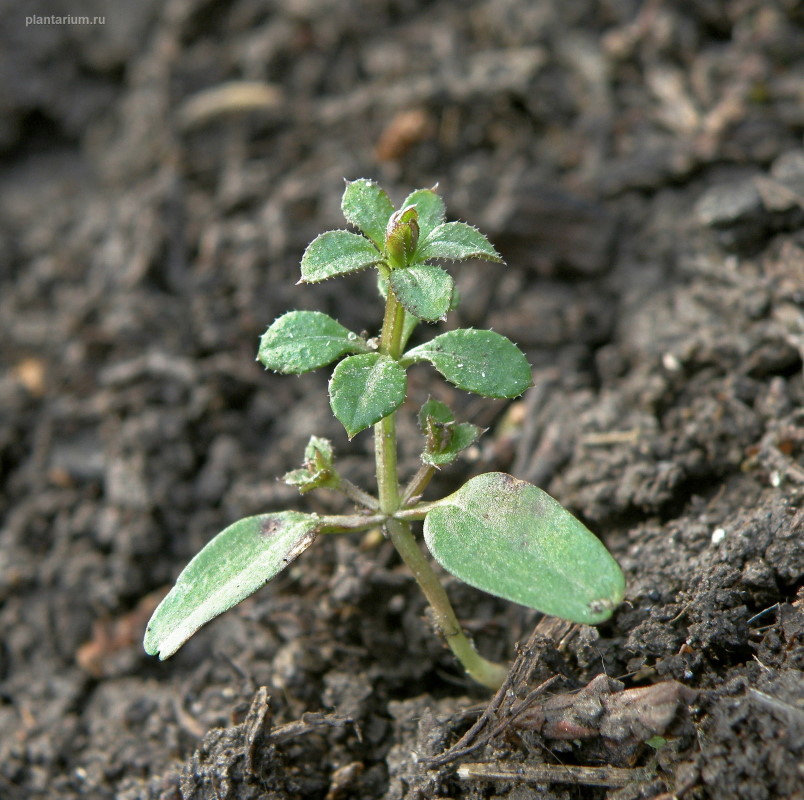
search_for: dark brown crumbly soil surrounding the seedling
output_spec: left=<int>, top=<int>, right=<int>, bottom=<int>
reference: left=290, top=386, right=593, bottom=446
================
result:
left=0, top=0, right=804, bottom=800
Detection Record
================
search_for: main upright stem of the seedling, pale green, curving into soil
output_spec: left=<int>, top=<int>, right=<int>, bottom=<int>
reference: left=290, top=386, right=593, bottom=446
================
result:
left=374, top=286, right=508, bottom=689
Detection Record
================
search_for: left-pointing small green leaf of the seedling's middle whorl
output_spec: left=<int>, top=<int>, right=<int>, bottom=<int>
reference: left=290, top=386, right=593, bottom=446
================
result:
left=257, top=311, right=368, bottom=375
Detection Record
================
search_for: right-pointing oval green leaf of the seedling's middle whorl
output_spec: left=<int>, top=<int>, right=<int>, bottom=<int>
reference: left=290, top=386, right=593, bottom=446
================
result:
left=402, top=328, right=532, bottom=397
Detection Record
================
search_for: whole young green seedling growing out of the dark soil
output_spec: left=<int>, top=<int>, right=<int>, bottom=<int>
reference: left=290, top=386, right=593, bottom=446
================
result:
left=144, top=180, right=624, bottom=688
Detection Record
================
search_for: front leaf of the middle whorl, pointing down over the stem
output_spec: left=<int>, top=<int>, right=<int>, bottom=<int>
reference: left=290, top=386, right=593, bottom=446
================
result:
left=329, top=353, right=407, bottom=439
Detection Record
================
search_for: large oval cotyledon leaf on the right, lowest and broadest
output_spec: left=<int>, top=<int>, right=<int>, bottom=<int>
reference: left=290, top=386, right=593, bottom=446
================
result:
left=424, top=472, right=625, bottom=625
